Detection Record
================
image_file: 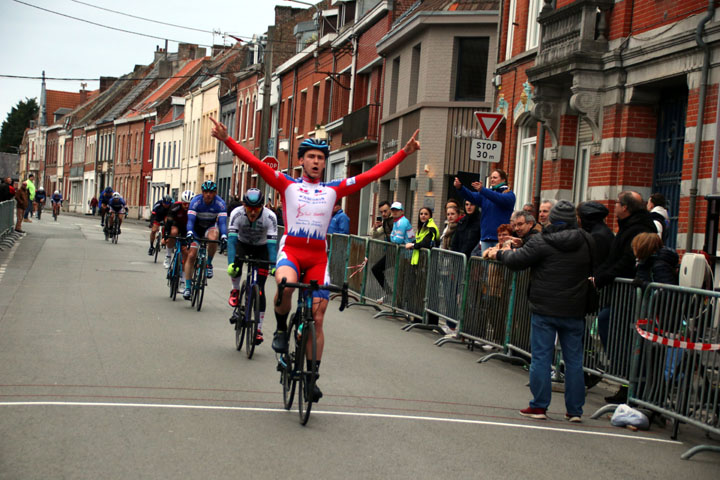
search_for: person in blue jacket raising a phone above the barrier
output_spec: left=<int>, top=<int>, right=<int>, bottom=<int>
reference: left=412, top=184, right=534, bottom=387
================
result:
left=454, top=168, right=515, bottom=251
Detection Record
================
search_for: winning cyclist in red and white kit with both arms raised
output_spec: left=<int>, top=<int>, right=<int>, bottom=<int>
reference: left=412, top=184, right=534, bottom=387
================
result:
left=210, top=117, right=420, bottom=401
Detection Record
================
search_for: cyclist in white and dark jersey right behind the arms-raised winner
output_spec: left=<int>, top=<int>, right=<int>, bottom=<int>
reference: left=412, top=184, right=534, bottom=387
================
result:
left=228, top=188, right=277, bottom=345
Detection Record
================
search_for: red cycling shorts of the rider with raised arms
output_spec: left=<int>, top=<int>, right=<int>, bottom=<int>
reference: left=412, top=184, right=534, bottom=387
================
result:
left=276, top=236, right=330, bottom=300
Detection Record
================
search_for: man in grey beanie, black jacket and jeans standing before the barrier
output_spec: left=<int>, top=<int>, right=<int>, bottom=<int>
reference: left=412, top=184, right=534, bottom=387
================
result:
left=490, top=200, right=594, bottom=422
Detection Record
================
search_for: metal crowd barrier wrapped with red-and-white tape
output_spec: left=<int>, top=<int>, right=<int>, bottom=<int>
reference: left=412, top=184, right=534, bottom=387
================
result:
left=629, top=283, right=720, bottom=459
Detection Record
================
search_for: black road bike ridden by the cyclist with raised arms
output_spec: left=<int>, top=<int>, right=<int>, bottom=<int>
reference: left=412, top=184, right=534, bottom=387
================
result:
left=276, top=278, right=348, bottom=425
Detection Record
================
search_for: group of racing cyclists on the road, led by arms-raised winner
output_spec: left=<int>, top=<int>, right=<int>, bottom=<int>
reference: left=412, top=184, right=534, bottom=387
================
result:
left=123, top=118, right=420, bottom=402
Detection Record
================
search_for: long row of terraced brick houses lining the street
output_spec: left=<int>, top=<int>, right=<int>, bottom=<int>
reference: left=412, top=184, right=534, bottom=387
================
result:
left=16, top=0, right=720, bottom=254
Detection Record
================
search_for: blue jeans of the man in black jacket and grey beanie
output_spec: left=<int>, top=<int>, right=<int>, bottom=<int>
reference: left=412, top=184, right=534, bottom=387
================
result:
left=530, top=313, right=585, bottom=416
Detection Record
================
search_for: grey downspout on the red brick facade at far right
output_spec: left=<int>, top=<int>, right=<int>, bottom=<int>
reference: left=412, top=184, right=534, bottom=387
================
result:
left=685, top=0, right=715, bottom=252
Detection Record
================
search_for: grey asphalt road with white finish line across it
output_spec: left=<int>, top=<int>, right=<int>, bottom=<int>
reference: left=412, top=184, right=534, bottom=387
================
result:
left=0, top=215, right=720, bottom=480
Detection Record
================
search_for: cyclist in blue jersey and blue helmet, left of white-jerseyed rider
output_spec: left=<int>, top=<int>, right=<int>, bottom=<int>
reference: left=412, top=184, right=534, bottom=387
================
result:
left=183, top=180, right=227, bottom=300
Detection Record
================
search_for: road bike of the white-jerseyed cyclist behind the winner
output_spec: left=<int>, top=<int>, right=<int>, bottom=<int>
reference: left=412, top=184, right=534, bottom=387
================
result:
left=230, top=257, right=275, bottom=359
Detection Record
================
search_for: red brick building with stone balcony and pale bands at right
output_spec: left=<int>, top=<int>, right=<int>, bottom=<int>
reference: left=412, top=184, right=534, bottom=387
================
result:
left=497, top=0, right=720, bottom=253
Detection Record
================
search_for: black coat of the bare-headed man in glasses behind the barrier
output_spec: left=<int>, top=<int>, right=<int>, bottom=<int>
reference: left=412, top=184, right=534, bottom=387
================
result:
left=595, top=209, right=657, bottom=288
